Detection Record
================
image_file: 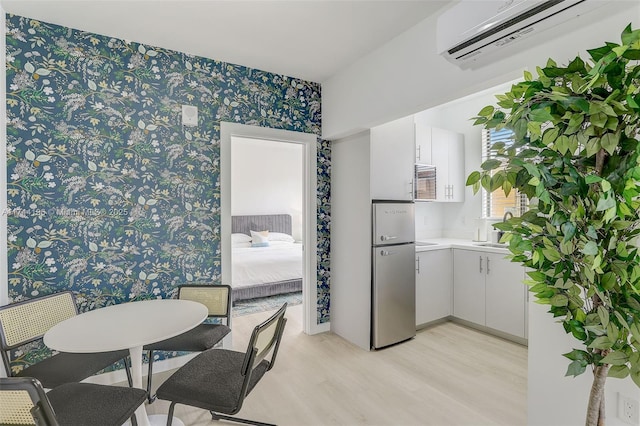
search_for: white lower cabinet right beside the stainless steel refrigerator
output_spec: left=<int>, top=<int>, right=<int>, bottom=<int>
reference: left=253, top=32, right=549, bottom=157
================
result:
left=416, top=249, right=453, bottom=326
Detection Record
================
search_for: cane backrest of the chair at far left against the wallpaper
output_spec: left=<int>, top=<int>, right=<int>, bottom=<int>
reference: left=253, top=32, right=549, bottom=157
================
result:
left=0, top=291, right=78, bottom=375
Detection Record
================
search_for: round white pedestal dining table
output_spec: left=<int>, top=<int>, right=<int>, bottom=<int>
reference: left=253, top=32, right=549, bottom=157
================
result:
left=44, top=299, right=208, bottom=426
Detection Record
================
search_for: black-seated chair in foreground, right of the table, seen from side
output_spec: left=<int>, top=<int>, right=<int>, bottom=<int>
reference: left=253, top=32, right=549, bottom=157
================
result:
left=157, top=303, right=287, bottom=426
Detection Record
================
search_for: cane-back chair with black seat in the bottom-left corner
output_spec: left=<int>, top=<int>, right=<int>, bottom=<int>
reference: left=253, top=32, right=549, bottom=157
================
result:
left=0, top=377, right=147, bottom=426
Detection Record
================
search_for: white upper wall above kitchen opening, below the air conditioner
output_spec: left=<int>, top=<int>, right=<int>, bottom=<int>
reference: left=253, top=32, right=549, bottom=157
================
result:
left=322, top=0, right=640, bottom=140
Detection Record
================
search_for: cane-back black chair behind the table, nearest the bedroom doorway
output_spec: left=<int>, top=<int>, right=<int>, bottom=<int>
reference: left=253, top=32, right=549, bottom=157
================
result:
left=143, top=285, right=231, bottom=403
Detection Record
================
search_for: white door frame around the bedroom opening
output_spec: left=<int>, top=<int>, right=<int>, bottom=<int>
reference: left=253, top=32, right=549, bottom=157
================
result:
left=220, top=121, right=327, bottom=334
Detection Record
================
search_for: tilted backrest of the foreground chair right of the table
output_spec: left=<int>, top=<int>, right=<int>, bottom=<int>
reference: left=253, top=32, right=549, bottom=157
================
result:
left=242, top=303, right=287, bottom=377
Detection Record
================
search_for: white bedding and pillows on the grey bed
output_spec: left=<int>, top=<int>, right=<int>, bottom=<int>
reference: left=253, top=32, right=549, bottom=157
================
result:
left=231, top=241, right=302, bottom=287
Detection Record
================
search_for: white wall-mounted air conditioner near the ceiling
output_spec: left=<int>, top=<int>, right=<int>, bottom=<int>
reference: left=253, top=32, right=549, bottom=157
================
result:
left=437, top=0, right=606, bottom=68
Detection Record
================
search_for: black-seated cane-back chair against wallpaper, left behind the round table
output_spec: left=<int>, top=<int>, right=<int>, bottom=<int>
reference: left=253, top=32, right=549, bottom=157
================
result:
left=0, top=291, right=133, bottom=389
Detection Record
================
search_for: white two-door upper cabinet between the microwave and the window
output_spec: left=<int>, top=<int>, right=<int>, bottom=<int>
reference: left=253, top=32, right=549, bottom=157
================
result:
left=431, top=127, right=464, bottom=202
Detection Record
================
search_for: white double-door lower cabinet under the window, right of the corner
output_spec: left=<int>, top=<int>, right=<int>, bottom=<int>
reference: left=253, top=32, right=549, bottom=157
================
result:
left=453, top=249, right=527, bottom=338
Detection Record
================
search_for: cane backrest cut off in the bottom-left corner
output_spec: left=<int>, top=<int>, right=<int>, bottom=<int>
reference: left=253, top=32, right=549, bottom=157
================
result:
left=0, top=377, right=58, bottom=426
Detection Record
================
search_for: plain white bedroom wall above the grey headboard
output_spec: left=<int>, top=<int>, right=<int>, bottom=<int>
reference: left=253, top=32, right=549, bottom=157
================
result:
left=231, top=137, right=304, bottom=240
